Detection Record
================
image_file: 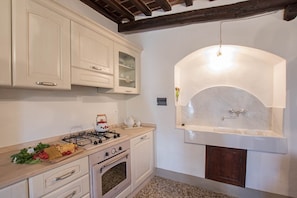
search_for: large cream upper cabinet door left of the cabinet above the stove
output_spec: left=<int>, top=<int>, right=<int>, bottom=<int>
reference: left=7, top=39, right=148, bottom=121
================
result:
left=12, top=0, right=70, bottom=89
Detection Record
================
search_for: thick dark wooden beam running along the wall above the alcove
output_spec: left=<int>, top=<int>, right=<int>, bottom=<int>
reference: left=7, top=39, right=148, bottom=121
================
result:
left=118, top=0, right=297, bottom=33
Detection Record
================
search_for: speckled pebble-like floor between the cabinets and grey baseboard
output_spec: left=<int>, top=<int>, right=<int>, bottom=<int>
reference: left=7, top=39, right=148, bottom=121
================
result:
left=134, top=176, right=233, bottom=198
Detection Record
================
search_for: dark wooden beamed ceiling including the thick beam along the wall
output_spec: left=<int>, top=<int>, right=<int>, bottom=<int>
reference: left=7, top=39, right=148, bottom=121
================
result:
left=80, top=0, right=297, bottom=33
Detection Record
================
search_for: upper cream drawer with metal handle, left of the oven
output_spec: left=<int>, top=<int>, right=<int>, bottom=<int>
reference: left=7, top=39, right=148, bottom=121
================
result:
left=29, top=157, right=89, bottom=197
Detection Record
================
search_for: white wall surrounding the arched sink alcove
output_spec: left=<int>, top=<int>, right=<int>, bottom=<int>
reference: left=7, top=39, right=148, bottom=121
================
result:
left=127, top=11, right=297, bottom=197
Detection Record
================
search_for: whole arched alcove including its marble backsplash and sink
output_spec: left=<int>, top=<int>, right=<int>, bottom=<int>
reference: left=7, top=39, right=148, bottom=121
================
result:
left=175, top=45, right=287, bottom=152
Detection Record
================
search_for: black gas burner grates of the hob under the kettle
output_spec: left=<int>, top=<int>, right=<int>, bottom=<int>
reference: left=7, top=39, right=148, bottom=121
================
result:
left=62, top=130, right=121, bottom=146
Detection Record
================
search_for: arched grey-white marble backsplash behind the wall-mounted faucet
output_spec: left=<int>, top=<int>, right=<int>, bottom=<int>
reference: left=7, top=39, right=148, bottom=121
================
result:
left=177, top=86, right=283, bottom=130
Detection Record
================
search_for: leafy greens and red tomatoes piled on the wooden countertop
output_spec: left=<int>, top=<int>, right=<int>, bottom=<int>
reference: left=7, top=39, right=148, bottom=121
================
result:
left=10, top=142, right=50, bottom=164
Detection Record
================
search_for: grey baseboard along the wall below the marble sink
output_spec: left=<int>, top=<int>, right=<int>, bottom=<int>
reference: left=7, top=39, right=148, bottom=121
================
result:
left=156, top=168, right=288, bottom=198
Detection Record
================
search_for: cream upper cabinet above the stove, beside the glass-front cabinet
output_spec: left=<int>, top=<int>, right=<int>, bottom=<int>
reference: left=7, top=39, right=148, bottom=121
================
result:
left=71, top=21, right=114, bottom=88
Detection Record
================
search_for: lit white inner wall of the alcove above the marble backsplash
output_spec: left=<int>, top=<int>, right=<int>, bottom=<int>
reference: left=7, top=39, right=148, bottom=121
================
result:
left=175, top=45, right=286, bottom=108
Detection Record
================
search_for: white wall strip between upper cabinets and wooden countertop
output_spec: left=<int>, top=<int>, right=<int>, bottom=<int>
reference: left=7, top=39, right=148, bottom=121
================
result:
left=0, top=86, right=126, bottom=147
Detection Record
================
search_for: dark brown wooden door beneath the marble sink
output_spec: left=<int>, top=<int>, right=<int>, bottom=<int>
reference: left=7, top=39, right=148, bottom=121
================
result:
left=205, top=145, right=247, bottom=187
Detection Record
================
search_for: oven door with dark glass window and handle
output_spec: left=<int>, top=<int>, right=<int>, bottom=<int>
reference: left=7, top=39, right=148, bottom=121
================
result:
left=92, top=150, right=131, bottom=198
